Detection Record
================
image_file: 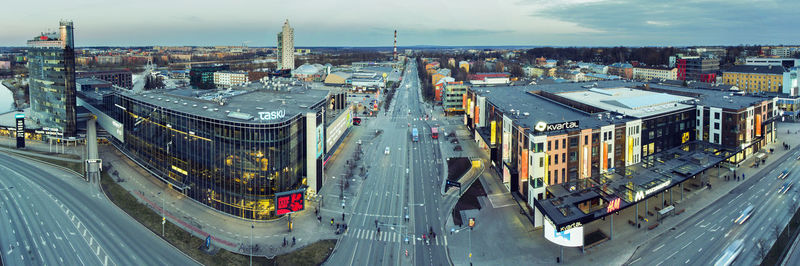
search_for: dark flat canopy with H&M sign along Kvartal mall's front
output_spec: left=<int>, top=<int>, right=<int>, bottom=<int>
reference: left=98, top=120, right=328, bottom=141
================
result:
left=534, top=141, right=736, bottom=231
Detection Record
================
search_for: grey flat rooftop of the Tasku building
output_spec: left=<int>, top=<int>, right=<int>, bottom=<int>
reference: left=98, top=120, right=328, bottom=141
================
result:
left=120, top=84, right=329, bottom=124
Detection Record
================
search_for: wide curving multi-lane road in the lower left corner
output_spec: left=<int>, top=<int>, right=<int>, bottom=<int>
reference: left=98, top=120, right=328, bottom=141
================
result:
left=0, top=153, right=197, bottom=265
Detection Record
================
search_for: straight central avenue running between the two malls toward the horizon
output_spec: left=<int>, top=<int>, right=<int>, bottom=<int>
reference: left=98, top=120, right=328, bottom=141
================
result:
left=327, top=60, right=448, bottom=265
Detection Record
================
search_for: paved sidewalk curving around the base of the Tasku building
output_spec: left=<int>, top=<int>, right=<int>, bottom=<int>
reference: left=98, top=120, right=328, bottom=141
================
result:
left=93, top=122, right=376, bottom=257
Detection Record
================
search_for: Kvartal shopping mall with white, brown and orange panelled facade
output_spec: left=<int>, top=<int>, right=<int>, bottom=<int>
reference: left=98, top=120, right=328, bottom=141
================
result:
left=463, top=81, right=777, bottom=234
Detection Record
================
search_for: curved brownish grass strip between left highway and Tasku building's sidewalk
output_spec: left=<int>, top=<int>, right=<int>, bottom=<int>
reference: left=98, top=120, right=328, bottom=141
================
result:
left=101, top=173, right=336, bottom=265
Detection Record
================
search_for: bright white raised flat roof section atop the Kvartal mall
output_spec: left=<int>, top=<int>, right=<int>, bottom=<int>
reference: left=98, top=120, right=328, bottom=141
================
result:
left=558, top=87, right=693, bottom=118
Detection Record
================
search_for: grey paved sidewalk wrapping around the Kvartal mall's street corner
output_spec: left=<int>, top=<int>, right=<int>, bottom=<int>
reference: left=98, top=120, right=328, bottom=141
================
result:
left=447, top=123, right=800, bottom=265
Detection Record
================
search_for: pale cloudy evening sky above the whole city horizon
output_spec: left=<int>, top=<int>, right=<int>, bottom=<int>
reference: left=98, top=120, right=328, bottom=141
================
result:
left=0, top=0, right=800, bottom=47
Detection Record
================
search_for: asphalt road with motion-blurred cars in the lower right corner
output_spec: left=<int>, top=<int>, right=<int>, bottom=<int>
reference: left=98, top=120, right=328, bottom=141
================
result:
left=626, top=151, right=800, bottom=266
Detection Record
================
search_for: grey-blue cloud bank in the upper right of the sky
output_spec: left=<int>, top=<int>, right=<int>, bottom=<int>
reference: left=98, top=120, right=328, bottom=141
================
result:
left=533, top=0, right=800, bottom=44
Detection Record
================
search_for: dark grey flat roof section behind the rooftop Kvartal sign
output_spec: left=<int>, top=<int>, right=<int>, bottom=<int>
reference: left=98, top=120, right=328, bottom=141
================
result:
left=472, top=86, right=629, bottom=134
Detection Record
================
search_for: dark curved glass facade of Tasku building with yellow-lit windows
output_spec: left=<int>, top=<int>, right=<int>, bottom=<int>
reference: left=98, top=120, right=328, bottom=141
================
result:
left=114, top=95, right=316, bottom=220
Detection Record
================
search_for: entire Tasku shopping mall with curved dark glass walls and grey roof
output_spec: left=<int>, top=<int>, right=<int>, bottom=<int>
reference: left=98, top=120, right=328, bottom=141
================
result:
left=78, top=83, right=352, bottom=220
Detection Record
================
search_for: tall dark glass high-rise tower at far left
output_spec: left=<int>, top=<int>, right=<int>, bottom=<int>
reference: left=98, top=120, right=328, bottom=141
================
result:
left=28, top=21, right=76, bottom=137
